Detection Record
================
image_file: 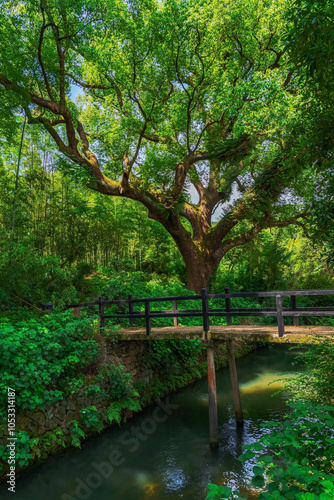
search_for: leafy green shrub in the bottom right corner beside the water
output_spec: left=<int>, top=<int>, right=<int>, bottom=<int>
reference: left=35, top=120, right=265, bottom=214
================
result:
left=239, top=400, right=334, bottom=500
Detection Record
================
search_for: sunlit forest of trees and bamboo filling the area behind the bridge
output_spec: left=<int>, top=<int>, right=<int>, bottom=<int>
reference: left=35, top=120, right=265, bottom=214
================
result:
left=0, top=0, right=334, bottom=309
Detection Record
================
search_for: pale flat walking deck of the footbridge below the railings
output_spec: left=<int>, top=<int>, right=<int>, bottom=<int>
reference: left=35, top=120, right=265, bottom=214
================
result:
left=117, top=325, right=334, bottom=343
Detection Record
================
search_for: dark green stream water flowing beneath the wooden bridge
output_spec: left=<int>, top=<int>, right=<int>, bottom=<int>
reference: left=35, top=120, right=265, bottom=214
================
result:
left=0, top=345, right=302, bottom=500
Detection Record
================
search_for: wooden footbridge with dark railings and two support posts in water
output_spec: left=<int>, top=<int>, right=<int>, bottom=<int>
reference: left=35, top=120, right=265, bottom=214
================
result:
left=44, top=288, right=334, bottom=447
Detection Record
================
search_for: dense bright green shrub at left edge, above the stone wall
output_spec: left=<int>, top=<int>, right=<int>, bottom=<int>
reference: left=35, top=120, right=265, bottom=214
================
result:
left=0, top=311, right=99, bottom=417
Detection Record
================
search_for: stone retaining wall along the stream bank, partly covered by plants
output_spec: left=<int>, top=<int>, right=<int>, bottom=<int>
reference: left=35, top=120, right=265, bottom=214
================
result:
left=0, top=338, right=255, bottom=480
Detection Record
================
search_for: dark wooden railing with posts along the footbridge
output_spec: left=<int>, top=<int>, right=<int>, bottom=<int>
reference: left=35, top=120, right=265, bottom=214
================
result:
left=44, top=288, right=334, bottom=337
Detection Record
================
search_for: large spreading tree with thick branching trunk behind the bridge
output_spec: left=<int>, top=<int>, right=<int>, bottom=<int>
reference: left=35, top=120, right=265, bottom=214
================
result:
left=0, top=0, right=307, bottom=291
